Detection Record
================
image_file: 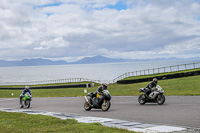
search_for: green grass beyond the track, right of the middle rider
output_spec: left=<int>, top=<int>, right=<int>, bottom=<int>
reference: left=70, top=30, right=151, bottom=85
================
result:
left=109, top=76, right=200, bottom=96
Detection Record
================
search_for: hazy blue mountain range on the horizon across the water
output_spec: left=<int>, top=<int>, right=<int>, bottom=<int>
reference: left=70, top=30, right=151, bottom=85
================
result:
left=0, top=56, right=200, bottom=67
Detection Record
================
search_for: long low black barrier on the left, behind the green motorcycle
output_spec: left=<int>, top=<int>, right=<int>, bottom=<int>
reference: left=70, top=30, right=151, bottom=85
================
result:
left=0, top=83, right=94, bottom=90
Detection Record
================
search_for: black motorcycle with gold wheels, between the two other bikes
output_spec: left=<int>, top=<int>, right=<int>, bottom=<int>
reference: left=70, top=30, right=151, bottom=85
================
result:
left=84, top=90, right=111, bottom=111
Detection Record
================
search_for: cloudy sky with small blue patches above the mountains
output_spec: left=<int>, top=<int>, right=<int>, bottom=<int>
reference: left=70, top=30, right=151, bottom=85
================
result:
left=0, top=0, right=200, bottom=62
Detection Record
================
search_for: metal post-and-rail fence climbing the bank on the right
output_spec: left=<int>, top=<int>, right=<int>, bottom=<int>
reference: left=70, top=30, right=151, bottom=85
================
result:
left=113, top=62, right=200, bottom=83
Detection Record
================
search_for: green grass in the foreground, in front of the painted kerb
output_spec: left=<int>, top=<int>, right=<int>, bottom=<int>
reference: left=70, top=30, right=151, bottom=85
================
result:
left=0, top=111, right=134, bottom=133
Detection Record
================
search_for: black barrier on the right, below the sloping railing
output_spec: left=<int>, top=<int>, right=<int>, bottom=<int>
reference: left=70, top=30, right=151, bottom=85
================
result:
left=117, top=70, right=200, bottom=84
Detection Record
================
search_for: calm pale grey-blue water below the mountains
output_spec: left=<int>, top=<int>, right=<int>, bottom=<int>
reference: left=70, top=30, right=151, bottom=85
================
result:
left=0, top=60, right=200, bottom=83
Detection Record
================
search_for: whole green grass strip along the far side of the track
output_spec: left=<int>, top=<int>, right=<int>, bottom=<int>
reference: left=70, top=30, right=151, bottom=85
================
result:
left=0, top=75, right=200, bottom=98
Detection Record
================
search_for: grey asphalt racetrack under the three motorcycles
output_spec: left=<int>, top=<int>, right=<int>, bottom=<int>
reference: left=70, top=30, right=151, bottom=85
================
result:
left=0, top=96, right=200, bottom=129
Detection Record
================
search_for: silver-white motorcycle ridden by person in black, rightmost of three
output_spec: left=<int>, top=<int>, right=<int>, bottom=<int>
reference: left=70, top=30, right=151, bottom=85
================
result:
left=138, top=85, right=165, bottom=105
